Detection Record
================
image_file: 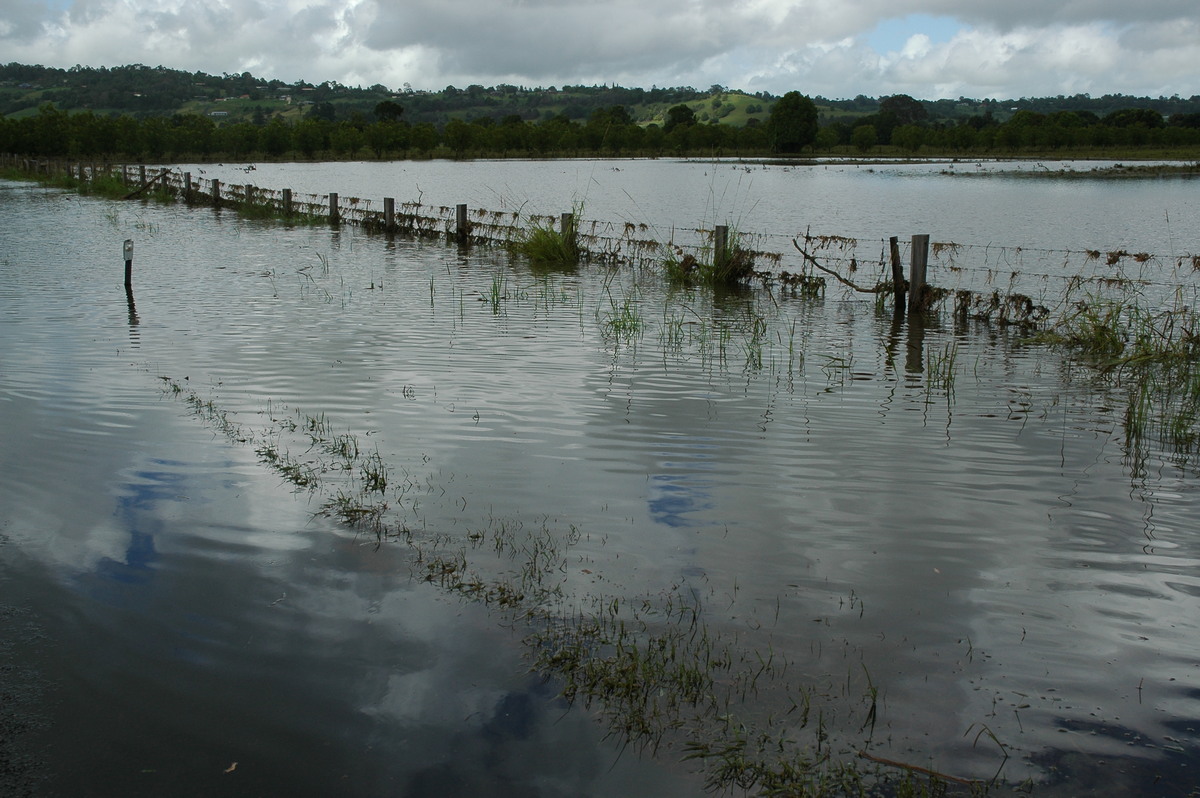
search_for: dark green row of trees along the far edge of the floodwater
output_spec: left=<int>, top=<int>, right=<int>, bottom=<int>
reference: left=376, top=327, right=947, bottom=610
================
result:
left=0, top=92, right=1200, bottom=161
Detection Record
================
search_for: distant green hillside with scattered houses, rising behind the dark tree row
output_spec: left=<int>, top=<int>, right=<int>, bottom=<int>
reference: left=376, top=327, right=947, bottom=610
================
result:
left=7, top=64, right=1200, bottom=127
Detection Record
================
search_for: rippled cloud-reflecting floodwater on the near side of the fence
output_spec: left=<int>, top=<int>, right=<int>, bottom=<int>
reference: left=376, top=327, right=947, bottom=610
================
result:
left=0, top=158, right=1200, bottom=796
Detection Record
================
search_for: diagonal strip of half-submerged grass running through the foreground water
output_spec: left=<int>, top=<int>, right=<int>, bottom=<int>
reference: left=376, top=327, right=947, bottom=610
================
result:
left=160, top=377, right=988, bottom=798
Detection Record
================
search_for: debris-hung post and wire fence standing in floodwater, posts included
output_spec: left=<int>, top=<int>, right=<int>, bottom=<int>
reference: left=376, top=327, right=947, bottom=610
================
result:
left=9, top=156, right=1200, bottom=326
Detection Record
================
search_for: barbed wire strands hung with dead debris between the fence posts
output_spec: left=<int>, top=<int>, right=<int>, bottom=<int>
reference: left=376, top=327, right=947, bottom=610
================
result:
left=54, top=164, right=1200, bottom=314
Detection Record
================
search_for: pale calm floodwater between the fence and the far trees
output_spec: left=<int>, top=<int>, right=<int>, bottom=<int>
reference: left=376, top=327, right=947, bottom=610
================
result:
left=173, top=158, right=1200, bottom=257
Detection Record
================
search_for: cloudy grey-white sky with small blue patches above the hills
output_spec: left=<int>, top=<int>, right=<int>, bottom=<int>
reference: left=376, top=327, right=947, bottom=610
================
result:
left=0, top=0, right=1200, bottom=100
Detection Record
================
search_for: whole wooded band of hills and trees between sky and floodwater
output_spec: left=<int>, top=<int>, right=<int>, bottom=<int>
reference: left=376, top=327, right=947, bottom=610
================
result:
left=0, top=65, right=1200, bottom=161
